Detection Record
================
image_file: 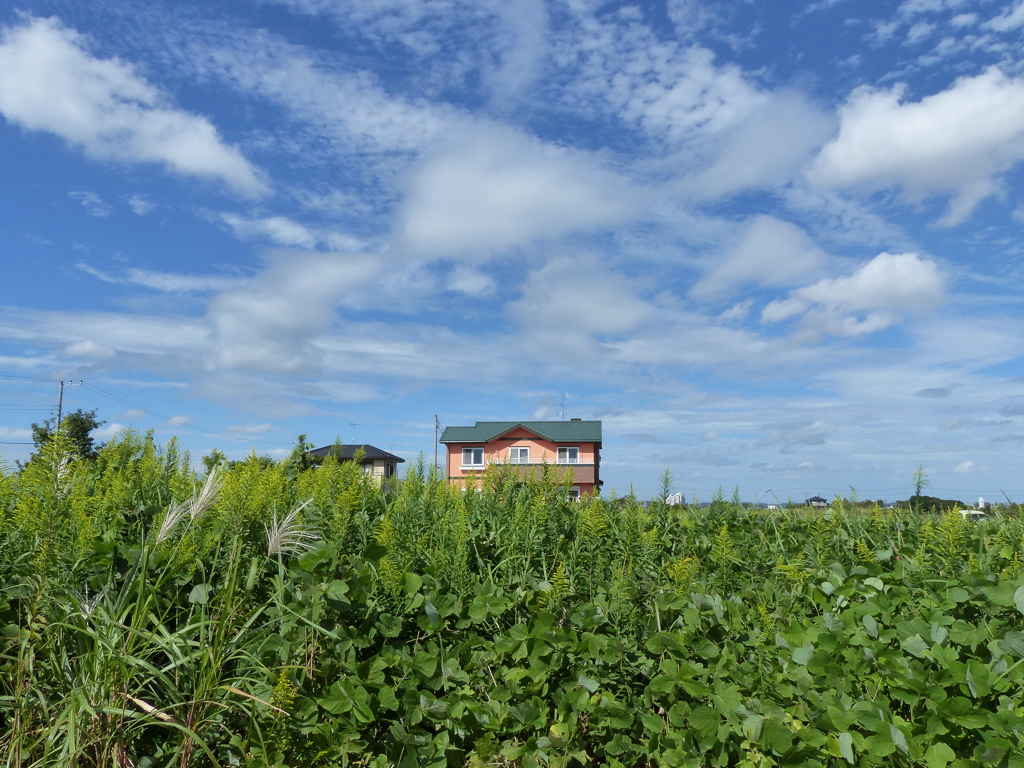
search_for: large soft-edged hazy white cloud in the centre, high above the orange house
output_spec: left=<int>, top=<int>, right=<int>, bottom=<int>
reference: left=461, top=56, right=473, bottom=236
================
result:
left=398, top=130, right=636, bottom=257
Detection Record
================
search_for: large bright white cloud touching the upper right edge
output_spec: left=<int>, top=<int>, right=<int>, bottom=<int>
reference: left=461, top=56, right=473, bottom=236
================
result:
left=808, top=68, right=1024, bottom=224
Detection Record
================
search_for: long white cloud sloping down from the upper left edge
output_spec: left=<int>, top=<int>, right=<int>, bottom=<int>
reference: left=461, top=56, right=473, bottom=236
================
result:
left=0, top=18, right=267, bottom=196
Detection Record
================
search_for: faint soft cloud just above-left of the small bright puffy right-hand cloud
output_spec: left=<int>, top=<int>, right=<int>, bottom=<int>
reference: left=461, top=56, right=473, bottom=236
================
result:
left=690, top=215, right=827, bottom=299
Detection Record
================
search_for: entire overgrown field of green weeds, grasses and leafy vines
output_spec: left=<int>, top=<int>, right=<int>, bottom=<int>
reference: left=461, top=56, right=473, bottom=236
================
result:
left=0, top=433, right=1024, bottom=768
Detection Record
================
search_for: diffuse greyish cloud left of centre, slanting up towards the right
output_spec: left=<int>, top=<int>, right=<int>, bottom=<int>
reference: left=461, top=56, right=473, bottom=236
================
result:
left=208, top=252, right=382, bottom=374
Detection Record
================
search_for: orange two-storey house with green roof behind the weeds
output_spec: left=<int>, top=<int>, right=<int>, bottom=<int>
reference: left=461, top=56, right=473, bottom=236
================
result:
left=440, top=419, right=601, bottom=497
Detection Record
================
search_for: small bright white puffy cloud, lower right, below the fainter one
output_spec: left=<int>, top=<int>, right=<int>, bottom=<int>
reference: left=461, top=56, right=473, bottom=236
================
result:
left=761, top=253, right=944, bottom=336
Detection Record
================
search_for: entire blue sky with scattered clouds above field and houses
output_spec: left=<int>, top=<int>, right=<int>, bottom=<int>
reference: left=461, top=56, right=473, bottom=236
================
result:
left=0, top=0, right=1024, bottom=502
